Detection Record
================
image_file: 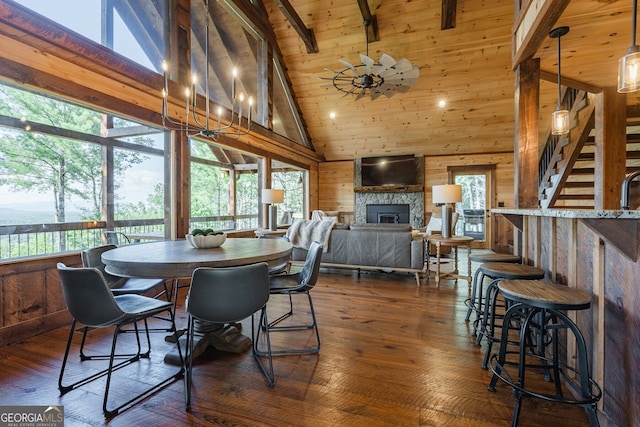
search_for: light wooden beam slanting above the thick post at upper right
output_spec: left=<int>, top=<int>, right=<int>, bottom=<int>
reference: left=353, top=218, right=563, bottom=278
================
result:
left=511, top=0, right=569, bottom=70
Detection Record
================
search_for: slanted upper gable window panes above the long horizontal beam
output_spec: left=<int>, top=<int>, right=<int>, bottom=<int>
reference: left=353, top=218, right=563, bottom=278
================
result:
left=16, top=0, right=310, bottom=146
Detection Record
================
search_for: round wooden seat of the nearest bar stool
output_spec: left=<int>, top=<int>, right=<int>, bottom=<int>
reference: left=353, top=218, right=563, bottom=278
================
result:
left=498, top=280, right=591, bottom=310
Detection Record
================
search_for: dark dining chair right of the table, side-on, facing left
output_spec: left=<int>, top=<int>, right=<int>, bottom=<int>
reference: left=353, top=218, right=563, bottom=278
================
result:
left=256, top=241, right=323, bottom=355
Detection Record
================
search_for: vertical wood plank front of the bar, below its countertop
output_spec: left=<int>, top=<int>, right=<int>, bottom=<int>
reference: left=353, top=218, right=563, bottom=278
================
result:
left=523, top=216, right=640, bottom=426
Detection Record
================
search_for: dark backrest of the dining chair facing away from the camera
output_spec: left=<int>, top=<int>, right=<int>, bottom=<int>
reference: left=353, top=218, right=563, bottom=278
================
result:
left=186, top=262, right=269, bottom=323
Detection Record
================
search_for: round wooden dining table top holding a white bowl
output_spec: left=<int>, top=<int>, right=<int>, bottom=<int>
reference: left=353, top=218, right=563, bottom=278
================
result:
left=102, top=238, right=293, bottom=279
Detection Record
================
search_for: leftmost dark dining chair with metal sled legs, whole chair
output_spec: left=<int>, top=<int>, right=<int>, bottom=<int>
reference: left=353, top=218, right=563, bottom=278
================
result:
left=57, top=263, right=184, bottom=418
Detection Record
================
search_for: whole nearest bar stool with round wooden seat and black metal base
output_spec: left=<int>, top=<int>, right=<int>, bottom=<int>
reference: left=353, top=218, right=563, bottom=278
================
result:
left=488, top=280, right=602, bottom=426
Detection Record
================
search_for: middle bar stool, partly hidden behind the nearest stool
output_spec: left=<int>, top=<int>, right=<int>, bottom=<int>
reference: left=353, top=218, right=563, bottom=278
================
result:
left=474, top=262, right=545, bottom=369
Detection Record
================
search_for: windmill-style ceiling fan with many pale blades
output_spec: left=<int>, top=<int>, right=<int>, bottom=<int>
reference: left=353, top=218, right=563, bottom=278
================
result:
left=320, top=19, right=420, bottom=100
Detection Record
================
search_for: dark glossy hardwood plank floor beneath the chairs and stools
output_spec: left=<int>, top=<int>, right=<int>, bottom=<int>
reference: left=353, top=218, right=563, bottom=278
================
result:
left=0, top=260, right=588, bottom=427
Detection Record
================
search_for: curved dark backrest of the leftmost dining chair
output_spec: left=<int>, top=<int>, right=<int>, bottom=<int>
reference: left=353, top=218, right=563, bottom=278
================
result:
left=57, top=262, right=125, bottom=327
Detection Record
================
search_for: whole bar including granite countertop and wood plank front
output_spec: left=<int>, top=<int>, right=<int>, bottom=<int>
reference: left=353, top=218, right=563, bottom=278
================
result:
left=492, top=209, right=640, bottom=426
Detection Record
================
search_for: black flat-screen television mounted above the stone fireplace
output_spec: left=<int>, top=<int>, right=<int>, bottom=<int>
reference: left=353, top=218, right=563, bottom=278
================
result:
left=360, top=154, right=418, bottom=187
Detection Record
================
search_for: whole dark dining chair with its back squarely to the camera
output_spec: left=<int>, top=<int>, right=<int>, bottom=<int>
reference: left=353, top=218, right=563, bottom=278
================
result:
left=185, top=262, right=275, bottom=411
